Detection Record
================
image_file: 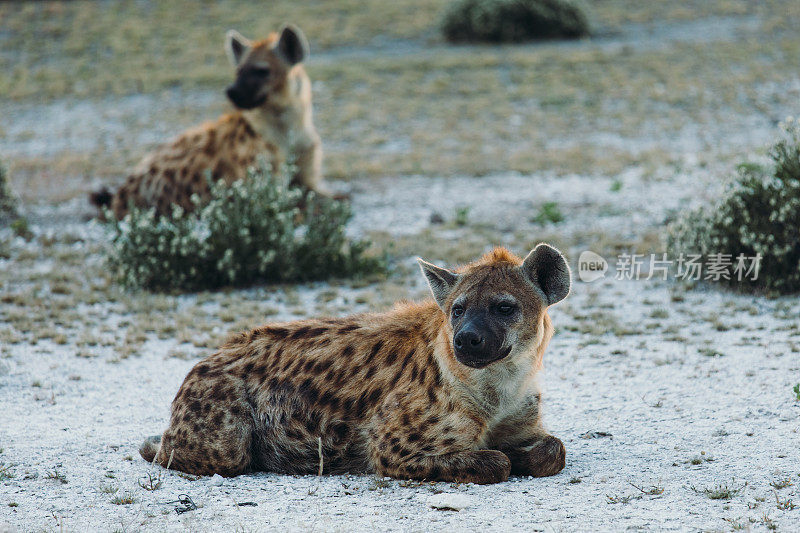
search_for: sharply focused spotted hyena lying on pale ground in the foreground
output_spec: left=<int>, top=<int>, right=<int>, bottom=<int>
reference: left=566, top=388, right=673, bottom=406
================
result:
left=140, top=244, right=570, bottom=483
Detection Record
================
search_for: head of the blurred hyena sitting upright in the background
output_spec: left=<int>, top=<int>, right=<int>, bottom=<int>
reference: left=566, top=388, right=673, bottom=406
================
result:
left=225, top=26, right=308, bottom=109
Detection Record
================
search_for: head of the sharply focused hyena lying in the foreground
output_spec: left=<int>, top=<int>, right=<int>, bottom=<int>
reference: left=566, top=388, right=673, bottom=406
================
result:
left=421, top=245, right=570, bottom=368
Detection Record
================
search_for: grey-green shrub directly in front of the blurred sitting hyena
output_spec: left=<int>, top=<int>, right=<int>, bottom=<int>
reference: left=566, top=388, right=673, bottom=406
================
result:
left=108, top=165, right=386, bottom=291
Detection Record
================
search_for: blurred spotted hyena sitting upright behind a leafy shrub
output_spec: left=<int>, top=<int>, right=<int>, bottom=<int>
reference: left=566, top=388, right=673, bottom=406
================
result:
left=90, top=25, right=328, bottom=219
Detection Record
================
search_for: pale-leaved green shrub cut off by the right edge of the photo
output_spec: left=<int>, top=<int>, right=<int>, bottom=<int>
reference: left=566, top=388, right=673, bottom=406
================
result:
left=668, top=120, right=800, bottom=293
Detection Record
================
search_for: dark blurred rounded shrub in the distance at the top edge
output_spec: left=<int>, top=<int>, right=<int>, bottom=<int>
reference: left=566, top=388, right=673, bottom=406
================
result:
left=441, top=0, right=589, bottom=43
